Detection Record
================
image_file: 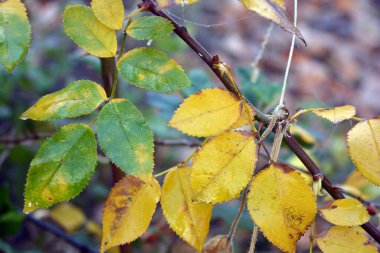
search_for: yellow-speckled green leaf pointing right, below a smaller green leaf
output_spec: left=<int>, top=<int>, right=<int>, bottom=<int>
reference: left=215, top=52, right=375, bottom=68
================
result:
left=117, top=47, right=191, bottom=92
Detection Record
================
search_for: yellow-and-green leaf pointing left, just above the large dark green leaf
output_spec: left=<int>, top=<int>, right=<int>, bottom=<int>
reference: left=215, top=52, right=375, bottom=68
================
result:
left=21, top=80, right=107, bottom=120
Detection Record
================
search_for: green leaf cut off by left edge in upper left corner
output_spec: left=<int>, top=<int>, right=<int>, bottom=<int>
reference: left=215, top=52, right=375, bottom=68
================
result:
left=0, top=0, right=31, bottom=73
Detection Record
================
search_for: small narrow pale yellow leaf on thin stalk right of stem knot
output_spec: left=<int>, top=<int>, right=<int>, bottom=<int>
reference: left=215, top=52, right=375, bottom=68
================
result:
left=311, top=105, right=356, bottom=124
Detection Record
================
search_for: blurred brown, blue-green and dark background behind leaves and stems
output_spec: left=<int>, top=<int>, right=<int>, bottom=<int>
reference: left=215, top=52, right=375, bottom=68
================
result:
left=0, top=0, right=380, bottom=252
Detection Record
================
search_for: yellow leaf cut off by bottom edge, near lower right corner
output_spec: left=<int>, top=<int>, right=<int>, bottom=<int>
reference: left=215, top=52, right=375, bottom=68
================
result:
left=317, top=226, right=378, bottom=253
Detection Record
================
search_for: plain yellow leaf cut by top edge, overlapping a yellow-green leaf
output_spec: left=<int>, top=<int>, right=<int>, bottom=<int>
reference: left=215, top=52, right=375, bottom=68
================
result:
left=91, top=0, right=124, bottom=30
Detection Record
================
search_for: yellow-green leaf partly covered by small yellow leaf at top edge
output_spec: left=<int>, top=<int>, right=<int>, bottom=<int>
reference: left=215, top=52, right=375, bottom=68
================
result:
left=63, top=5, right=117, bottom=57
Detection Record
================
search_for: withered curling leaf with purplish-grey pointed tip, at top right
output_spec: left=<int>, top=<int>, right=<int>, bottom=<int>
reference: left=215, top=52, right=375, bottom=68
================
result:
left=240, top=0, right=305, bottom=43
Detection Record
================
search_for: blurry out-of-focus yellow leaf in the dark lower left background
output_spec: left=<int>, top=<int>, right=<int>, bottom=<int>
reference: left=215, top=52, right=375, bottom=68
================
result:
left=50, top=203, right=86, bottom=233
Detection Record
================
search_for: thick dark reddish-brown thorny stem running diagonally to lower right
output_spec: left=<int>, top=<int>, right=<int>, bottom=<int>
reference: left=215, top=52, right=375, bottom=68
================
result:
left=139, top=0, right=380, bottom=243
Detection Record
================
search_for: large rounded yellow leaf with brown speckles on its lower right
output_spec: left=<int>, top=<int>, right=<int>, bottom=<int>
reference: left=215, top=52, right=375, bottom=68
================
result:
left=248, top=163, right=317, bottom=252
